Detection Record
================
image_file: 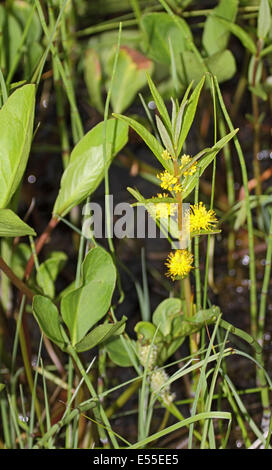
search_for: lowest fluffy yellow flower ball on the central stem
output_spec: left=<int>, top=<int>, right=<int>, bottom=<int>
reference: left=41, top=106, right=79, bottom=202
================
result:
left=165, top=250, right=194, bottom=281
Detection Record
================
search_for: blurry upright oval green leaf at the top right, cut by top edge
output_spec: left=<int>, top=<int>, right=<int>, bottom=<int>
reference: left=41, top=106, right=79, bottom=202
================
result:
left=202, top=0, right=239, bottom=55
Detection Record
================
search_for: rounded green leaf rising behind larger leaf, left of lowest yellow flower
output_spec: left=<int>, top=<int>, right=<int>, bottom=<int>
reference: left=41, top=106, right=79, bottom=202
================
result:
left=82, top=246, right=116, bottom=289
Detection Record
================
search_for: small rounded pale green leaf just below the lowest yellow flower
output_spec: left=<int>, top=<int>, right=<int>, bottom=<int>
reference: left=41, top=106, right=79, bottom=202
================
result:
left=152, top=299, right=182, bottom=336
